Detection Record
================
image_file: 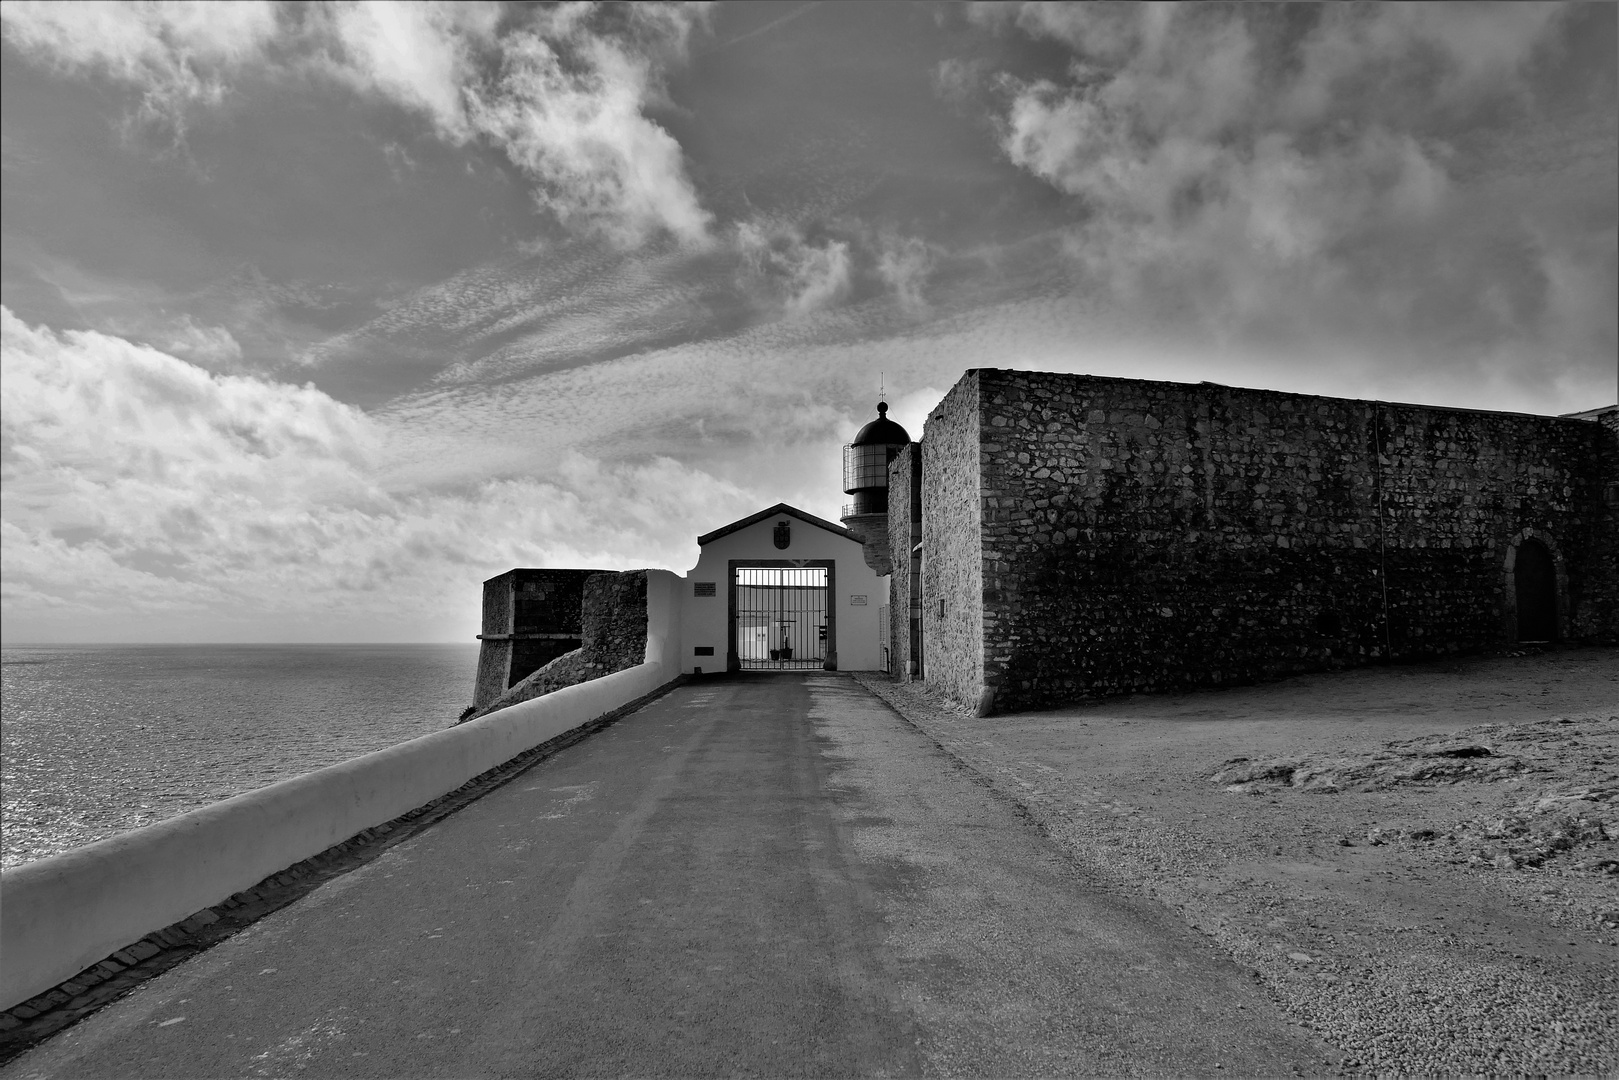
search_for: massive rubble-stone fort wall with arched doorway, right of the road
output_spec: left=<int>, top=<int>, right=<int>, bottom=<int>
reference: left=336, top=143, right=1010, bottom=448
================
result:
left=923, top=369, right=1619, bottom=711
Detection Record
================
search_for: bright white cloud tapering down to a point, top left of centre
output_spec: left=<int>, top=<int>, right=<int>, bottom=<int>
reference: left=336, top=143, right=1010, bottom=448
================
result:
left=325, top=3, right=712, bottom=248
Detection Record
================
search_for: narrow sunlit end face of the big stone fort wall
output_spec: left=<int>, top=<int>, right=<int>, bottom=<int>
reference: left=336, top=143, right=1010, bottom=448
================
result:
left=921, top=371, right=984, bottom=703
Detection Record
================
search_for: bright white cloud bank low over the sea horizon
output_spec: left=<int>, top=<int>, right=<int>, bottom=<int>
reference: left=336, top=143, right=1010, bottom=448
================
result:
left=0, top=308, right=754, bottom=638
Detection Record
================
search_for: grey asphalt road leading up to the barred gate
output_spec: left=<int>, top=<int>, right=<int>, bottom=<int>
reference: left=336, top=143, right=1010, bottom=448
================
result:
left=0, top=674, right=1331, bottom=1080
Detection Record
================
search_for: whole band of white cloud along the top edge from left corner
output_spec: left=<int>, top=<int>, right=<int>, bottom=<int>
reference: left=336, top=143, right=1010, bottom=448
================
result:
left=0, top=0, right=711, bottom=246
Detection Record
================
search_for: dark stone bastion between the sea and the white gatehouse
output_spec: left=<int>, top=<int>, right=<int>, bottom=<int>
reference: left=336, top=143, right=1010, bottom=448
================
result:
left=461, top=570, right=646, bottom=724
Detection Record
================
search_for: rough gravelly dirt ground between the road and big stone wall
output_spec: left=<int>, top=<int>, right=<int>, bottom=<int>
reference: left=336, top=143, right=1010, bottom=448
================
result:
left=861, top=649, right=1619, bottom=1075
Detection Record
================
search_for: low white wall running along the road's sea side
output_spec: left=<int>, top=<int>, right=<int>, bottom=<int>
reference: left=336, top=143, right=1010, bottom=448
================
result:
left=0, top=570, right=680, bottom=1009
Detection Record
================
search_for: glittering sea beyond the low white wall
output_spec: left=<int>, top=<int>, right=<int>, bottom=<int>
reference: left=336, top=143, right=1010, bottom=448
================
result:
left=0, top=643, right=478, bottom=866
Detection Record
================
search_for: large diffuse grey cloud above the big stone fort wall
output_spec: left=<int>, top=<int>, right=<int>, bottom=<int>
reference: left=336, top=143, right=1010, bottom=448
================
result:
left=975, top=3, right=1614, bottom=356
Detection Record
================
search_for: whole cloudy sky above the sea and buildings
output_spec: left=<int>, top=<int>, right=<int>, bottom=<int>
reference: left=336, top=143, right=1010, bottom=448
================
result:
left=0, top=0, right=1619, bottom=643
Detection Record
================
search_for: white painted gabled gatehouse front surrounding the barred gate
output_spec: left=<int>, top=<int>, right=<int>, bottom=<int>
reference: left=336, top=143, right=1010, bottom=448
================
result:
left=680, top=515, right=889, bottom=672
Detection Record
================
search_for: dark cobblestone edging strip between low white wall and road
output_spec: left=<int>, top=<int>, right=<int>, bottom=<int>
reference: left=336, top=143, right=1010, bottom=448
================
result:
left=0, top=675, right=688, bottom=1065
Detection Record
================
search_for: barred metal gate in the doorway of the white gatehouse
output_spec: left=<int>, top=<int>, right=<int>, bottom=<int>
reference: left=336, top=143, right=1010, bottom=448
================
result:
left=730, top=567, right=832, bottom=672
